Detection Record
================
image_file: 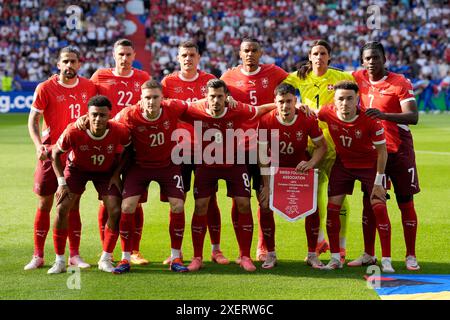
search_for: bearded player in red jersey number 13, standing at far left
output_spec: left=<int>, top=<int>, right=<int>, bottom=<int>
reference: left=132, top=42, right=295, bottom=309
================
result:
left=24, top=47, right=96, bottom=270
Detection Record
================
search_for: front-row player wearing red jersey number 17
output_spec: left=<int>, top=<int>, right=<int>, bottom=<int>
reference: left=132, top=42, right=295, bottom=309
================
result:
left=319, top=81, right=394, bottom=273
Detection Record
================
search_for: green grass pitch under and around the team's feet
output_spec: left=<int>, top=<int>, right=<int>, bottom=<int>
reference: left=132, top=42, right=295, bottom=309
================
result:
left=0, top=114, right=450, bottom=300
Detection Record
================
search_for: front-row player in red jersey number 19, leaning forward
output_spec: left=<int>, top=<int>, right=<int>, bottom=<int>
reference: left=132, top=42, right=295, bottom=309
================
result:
left=48, top=96, right=131, bottom=274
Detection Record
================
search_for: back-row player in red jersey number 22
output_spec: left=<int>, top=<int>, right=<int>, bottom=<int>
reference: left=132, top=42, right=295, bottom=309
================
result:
left=91, top=39, right=150, bottom=265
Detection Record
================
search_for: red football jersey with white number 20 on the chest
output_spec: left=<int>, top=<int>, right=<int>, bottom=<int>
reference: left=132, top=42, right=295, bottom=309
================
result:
left=116, top=100, right=188, bottom=168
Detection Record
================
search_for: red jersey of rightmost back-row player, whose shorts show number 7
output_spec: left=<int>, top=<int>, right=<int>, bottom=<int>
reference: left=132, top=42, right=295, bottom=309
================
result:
left=353, top=70, right=415, bottom=152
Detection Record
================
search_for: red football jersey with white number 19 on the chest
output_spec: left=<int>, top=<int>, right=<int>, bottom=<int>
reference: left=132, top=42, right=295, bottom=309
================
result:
left=57, top=121, right=131, bottom=172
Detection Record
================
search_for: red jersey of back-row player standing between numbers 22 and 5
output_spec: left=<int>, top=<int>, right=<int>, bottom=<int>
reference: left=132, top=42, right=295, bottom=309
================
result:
left=161, top=71, right=216, bottom=156
